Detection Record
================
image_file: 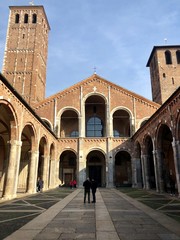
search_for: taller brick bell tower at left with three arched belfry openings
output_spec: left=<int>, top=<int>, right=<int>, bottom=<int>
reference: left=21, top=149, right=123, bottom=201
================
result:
left=2, top=5, right=50, bottom=105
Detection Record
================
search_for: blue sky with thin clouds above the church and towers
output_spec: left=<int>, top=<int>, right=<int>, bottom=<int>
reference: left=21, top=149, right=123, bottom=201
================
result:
left=0, top=0, right=180, bottom=100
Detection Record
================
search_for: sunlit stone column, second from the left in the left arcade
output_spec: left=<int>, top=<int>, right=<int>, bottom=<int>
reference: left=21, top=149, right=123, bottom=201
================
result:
left=27, top=151, right=39, bottom=193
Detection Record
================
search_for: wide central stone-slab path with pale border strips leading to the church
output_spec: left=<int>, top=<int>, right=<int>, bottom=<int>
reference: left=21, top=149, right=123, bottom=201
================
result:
left=5, top=188, right=180, bottom=240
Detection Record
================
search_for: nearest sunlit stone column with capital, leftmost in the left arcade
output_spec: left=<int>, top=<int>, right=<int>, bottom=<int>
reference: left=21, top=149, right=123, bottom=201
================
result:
left=3, top=140, right=22, bottom=199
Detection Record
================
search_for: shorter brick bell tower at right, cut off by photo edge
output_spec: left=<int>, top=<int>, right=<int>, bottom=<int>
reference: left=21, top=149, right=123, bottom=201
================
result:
left=147, top=45, right=180, bottom=104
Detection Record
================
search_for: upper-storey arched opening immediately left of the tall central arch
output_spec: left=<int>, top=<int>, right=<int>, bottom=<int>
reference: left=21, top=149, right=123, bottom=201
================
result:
left=60, top=110, right=79, bottom=137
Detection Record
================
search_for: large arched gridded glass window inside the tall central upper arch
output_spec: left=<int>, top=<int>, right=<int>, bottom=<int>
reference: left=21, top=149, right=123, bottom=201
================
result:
left=86, top=117, right=103, bottom=137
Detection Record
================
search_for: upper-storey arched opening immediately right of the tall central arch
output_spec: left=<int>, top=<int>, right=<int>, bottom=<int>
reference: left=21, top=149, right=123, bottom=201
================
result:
left=113, top=109, right=130, bottom=137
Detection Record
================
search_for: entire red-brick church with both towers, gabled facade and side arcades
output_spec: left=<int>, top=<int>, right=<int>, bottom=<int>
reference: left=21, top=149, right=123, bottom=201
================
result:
left=0, top=6, right=180, bottom=199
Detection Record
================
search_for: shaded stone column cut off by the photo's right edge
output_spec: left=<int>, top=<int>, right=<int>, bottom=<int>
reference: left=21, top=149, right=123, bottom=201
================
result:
left=172, top=139, right=180, bottom=196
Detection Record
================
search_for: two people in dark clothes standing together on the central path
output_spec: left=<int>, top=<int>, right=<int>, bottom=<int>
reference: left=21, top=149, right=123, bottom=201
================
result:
left=83, top=178, right=97, bottom=203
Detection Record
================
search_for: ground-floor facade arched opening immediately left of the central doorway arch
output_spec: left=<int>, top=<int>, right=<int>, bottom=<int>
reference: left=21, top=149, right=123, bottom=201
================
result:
left=59, top=150, right=77, bottom=186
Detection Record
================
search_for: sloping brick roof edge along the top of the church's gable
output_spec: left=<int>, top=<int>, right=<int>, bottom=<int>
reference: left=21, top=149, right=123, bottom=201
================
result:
left=34, top=74, right=160, bottom=108
